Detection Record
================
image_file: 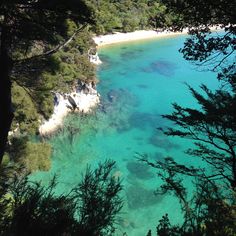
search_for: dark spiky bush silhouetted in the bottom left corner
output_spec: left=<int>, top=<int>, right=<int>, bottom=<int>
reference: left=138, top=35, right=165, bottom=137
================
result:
left=0, top=161, right=122, bottom=236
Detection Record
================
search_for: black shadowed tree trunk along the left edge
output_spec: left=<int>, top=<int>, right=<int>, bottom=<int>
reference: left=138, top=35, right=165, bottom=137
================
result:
left=0, top=27, right=13, bottom=165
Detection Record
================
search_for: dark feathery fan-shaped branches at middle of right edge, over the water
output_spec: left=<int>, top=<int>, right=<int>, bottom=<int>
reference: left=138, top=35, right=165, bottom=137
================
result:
left=160, top=86, right=236, bottom=188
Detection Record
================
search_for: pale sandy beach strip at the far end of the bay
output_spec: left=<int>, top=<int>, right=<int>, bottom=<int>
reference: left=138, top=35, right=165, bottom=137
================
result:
left=93, top=26, right=219, bottom=47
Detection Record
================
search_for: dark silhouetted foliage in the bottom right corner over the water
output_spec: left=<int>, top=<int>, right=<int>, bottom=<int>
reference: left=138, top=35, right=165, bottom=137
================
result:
left=141, top=157, right=236, bottom=236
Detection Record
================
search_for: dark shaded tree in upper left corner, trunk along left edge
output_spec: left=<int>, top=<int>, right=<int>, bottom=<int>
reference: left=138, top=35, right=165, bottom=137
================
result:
left=0, top=0, right=92, bottom=164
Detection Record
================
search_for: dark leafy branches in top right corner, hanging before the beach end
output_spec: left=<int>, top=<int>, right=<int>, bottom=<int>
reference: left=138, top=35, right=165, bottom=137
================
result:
left=162, top=0, right=236, bottom=89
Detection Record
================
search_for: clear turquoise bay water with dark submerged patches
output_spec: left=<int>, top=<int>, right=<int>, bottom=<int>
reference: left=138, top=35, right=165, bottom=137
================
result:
left=33, top=36, right=218, bottom=236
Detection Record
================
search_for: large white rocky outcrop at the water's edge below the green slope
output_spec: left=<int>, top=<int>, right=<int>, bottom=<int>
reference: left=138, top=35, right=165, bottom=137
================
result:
left=39, top=87, right=100, bottom=136
